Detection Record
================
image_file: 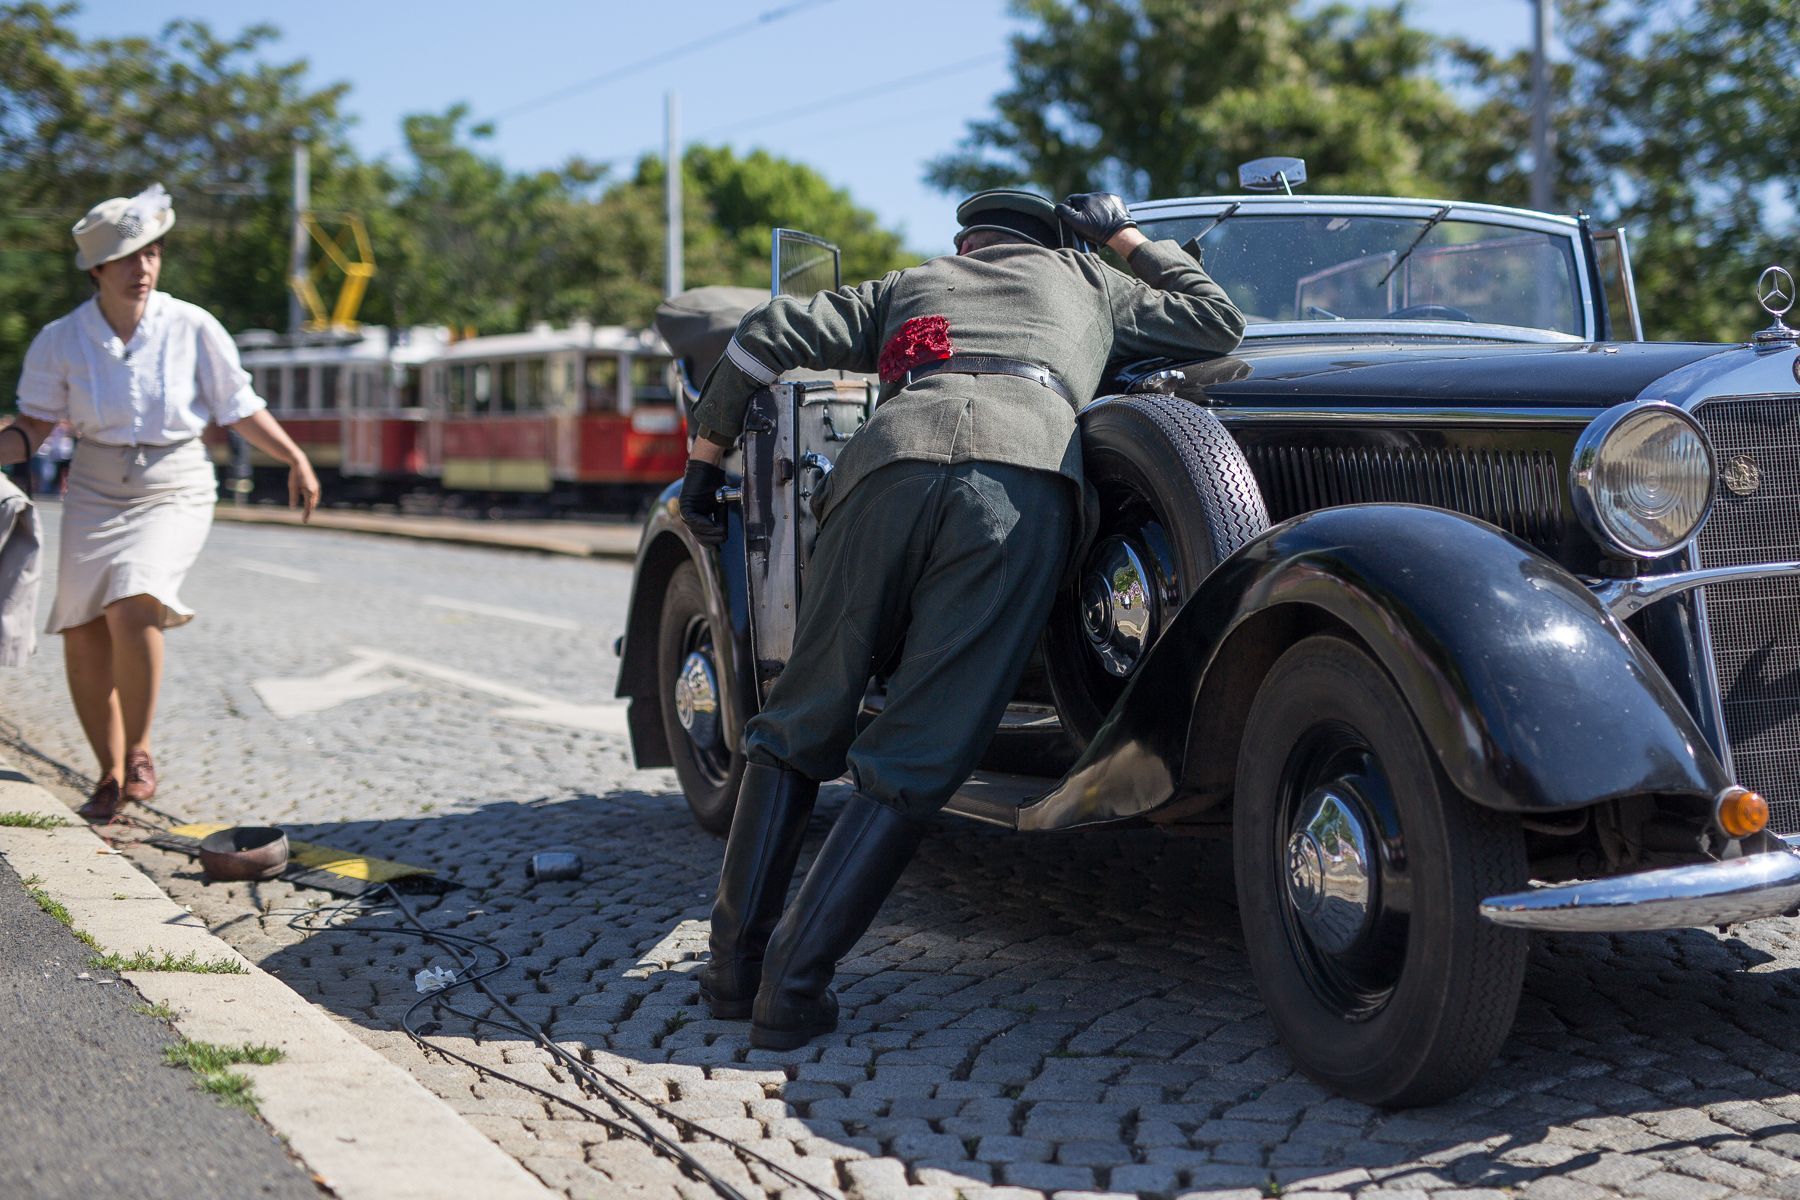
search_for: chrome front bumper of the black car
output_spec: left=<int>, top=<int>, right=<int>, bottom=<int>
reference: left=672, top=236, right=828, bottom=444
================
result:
left=1481, top=847, right=1800, bottom=934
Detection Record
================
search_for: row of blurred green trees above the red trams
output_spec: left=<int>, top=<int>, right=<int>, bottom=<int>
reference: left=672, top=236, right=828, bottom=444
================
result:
left=0, top=2, right=914, bottom=410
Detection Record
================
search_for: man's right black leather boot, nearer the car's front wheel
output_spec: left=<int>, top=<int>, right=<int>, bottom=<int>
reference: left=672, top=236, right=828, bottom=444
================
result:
left=751, top=793, right=923, bottom=1051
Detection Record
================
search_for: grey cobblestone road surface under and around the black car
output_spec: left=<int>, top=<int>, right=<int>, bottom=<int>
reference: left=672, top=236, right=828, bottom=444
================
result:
left=4, top=510, right=1800, bottom=1200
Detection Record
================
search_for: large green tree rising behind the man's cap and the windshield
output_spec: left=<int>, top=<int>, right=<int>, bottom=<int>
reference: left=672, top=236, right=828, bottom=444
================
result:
left=927, top=0, right=1492, bottom=198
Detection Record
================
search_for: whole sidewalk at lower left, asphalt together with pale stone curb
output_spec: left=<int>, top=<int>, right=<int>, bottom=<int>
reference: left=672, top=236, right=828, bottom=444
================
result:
left=0, top=759, right=547, bottom=1200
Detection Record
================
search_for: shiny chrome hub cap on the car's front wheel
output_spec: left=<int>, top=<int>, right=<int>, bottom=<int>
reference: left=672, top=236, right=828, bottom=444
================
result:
left=1287, top=788, right=1375, bottom=954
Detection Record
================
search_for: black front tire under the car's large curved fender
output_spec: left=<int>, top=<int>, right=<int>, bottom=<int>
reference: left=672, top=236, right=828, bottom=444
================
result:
left=1233, top=635, right=1526, bottom=1108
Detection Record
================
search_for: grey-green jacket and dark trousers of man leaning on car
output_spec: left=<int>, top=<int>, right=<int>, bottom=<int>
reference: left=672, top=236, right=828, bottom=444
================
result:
left=693, top=241, right=1244, bottom=817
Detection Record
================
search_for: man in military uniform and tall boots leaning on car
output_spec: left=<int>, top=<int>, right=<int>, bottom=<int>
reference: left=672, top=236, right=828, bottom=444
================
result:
left=680, top=191, right=1244, bottom=1049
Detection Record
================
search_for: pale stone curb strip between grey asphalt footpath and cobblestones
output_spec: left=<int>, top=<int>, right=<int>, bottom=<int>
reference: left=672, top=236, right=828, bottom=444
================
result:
left=0, top=757, right=554, bottom=1200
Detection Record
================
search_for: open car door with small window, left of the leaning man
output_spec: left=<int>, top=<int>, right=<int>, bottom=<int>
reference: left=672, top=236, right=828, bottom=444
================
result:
left=743, top=228, right=875, bottom=694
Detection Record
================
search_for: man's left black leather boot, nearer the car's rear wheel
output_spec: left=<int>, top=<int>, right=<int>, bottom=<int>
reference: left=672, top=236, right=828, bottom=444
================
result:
left=700, top=763, right=819, bottom=1020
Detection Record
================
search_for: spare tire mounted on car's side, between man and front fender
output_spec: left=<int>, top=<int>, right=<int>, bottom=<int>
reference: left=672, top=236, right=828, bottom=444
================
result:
left=1044, top=394, right=1269, bottom=747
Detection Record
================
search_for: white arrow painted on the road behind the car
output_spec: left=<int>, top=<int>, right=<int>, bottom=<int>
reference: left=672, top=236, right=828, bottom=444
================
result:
left=252, top=646, right=626, bottom=734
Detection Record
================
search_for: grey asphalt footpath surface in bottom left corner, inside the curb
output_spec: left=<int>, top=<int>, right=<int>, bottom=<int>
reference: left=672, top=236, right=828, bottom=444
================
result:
left=0, top=860, right=324, bottom=1200
